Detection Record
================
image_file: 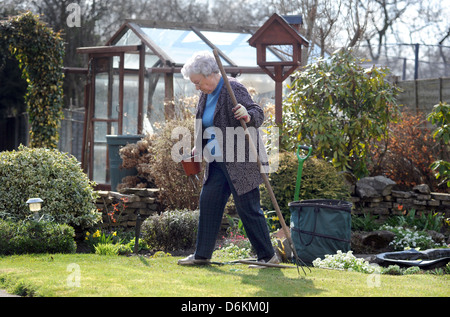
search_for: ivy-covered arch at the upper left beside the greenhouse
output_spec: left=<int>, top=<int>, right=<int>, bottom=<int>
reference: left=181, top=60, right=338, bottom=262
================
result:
left=0, top=12, right=64, bottom=148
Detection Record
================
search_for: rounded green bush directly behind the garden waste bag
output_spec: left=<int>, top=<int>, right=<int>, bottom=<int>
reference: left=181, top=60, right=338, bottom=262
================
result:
left=261, top=152, right=350, bottom=221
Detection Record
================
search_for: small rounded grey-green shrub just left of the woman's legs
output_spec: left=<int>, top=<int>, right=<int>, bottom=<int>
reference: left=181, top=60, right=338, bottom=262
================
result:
left=141, top=210, right=199, bottom=252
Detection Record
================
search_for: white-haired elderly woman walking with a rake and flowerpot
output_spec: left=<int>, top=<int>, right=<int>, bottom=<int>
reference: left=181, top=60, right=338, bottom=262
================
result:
left=178, top=52, right=278, bottom=265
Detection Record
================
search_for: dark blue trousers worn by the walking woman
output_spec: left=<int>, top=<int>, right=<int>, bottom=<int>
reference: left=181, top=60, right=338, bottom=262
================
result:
left=195, top=161, right=274, bottom=260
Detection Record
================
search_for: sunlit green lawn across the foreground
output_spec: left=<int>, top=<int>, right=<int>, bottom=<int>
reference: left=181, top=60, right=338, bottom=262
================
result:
left=0, top=254, right=450, bottom=297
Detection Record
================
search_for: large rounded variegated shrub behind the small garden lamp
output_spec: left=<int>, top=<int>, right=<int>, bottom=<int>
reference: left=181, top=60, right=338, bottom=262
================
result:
left=0, top=145, right=101, bottom=229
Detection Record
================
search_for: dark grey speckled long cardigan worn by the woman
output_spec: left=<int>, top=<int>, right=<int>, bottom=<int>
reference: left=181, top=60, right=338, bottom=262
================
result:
left=195, top=77, right=267, bottom=195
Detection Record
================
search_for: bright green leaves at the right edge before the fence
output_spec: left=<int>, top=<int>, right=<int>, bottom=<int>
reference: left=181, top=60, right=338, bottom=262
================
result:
left=427, top=102, right=450, bottom=187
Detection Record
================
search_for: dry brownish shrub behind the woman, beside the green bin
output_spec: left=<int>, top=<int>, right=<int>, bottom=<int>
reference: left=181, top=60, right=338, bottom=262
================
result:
left=119, top=97, right=202, bottom=210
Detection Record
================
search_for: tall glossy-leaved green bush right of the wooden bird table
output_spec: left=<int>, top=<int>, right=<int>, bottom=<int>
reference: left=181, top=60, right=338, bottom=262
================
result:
left=281, top=50, right=398, bottom=178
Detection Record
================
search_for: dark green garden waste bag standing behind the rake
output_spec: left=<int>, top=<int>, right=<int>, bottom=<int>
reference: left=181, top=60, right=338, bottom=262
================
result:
left=289, top=199, right=352, bottom=265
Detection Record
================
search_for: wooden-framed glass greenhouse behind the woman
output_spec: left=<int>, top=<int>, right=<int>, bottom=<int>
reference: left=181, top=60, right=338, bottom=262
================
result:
left=77, top=15, right=306, bottom=189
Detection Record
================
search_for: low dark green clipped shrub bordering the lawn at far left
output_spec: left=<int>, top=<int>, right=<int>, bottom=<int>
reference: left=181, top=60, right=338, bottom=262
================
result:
left=0, top=220, right=76, bottom=255
